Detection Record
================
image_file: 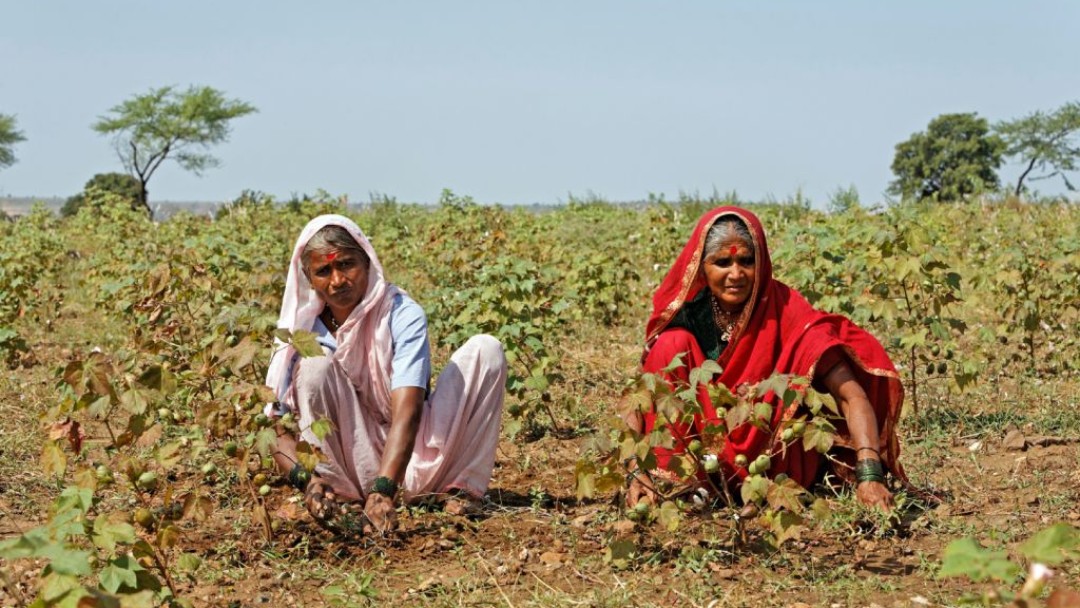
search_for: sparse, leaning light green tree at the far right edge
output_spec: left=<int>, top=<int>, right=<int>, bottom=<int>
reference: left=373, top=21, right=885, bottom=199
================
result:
left=994, top=102, right=1080, bottom=197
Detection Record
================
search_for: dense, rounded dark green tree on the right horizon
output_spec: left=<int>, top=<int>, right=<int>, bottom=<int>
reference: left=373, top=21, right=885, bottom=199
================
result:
left=889, top=112, right=1005, bottom=201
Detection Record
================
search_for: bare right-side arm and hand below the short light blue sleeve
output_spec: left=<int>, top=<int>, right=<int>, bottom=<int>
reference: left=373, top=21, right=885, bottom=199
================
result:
left=364, top=387, right=424, bottom=530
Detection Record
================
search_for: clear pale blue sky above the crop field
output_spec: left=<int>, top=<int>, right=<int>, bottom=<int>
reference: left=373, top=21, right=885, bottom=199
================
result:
left=0, top=0, right=1080, bottom=205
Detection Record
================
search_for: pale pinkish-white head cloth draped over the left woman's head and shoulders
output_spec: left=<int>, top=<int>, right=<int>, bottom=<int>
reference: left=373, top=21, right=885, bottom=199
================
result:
left=266, top=214, right=403, bottom=411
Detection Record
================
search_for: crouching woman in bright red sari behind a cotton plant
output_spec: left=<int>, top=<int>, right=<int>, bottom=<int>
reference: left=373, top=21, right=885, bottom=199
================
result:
left=627, top=206, right=906, bottom=509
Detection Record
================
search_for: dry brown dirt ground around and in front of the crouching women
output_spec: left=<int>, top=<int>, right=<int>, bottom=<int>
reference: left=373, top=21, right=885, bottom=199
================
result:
left=0, top=317, right=1080, bottom=607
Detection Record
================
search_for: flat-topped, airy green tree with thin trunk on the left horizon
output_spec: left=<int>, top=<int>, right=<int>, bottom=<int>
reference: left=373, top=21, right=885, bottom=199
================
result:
left=93, top=86, right=257, bottom=213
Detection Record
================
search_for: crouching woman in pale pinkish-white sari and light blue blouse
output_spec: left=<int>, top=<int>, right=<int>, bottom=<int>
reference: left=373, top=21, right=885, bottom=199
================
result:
left=267, top=215, right=507, bottom=530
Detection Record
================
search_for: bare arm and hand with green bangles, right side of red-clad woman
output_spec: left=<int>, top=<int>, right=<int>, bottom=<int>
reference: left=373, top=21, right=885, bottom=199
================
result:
left=822, top=361, right=892, bottom=509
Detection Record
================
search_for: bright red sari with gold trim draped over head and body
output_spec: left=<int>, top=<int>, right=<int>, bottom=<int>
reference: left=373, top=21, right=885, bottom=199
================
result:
left=642, top=206, right=906, bottom=487
